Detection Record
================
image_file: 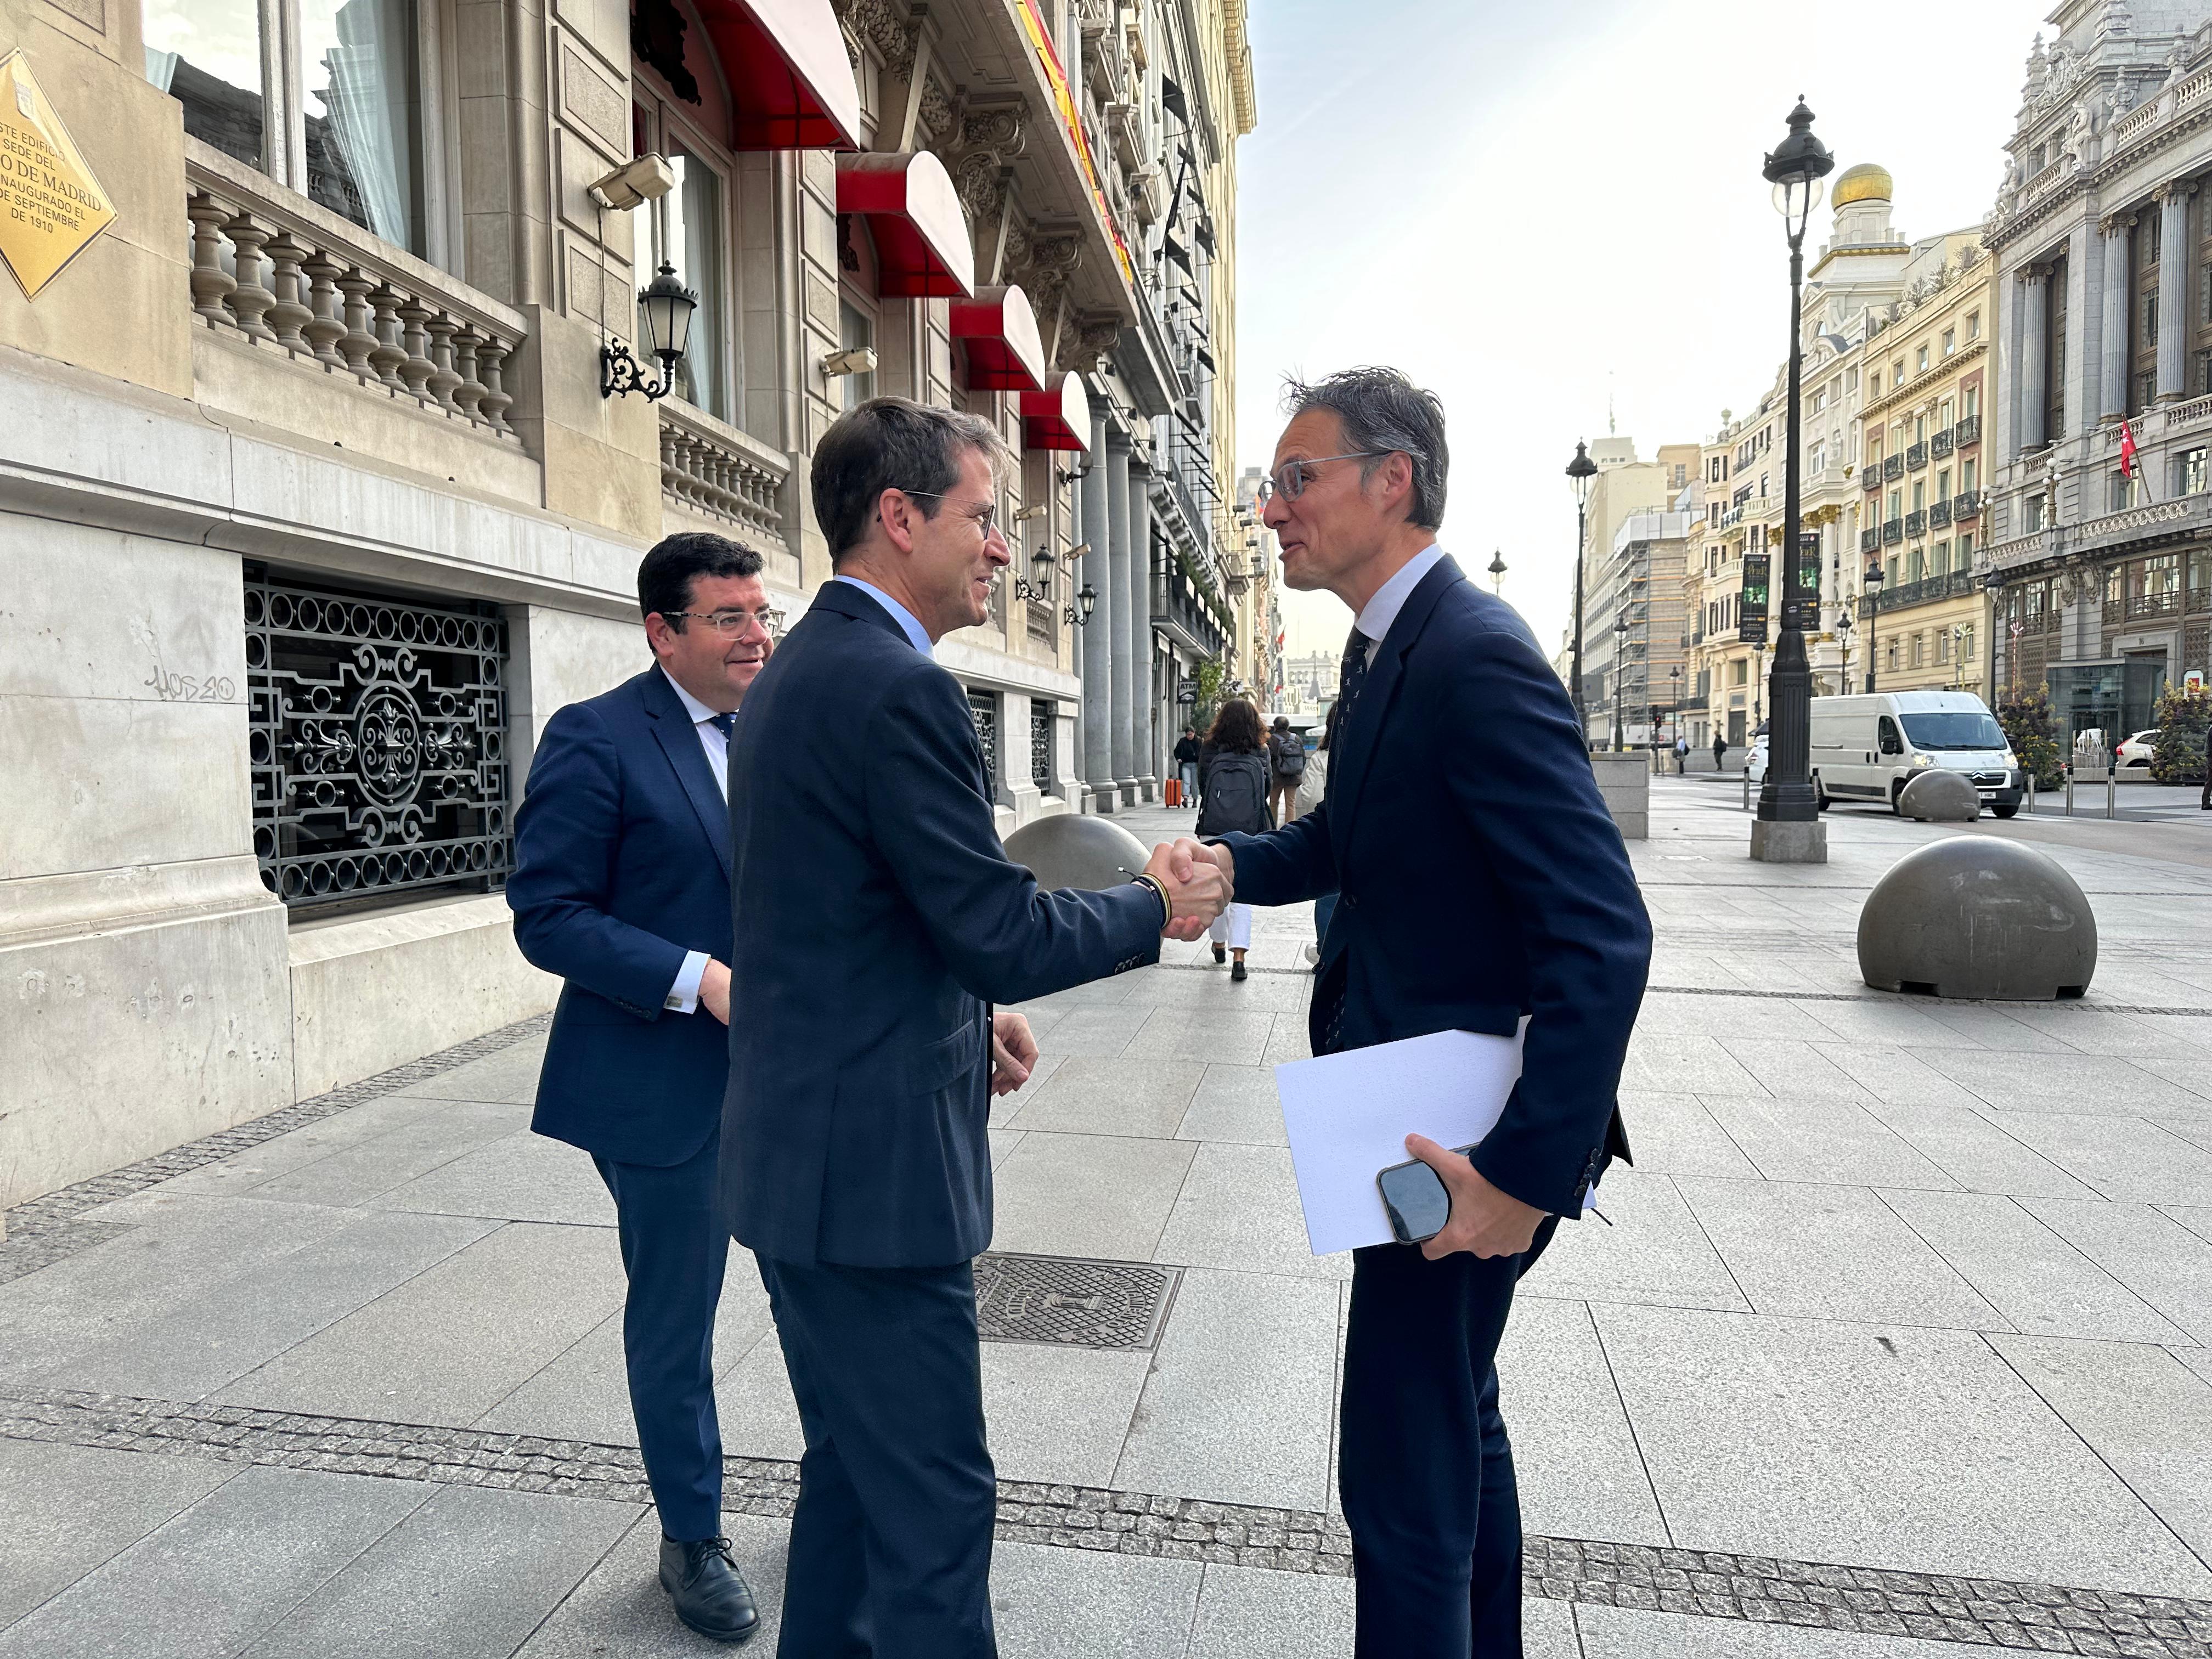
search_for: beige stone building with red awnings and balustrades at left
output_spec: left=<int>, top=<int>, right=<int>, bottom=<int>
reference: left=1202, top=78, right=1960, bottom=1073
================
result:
left=0, top=0, right=1254, bottom=1203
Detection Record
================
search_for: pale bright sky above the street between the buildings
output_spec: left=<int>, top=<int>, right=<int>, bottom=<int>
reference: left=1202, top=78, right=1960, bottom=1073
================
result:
left=1237, top=0, right=2055, bottom=654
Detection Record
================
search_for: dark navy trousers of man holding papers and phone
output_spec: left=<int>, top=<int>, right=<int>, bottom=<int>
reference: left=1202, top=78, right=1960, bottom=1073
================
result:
left=1336, top=1221, right=1555, bottom=1659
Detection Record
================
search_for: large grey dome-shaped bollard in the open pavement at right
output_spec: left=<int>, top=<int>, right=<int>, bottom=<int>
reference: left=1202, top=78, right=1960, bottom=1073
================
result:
left=1858, top=836, right=2097, bottom=1002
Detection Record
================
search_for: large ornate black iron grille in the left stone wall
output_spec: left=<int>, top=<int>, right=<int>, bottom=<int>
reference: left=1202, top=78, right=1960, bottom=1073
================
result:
left=246, top=568, right=513, bottom=905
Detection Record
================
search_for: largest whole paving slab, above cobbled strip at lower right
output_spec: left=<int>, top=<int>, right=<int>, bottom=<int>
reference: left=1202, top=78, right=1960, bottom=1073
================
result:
left=1590, top=1307, right=2212, bottom=1597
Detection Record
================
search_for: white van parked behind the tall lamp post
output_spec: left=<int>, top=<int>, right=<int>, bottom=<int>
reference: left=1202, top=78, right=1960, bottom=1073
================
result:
left=1812, top=692, right=2026, bottom=819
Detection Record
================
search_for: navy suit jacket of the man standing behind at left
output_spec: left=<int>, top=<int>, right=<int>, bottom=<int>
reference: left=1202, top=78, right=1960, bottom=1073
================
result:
left=506, top=668, right=730, bottom=1166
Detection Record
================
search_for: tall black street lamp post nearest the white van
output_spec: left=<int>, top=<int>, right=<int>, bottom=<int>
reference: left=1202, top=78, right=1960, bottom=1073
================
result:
left=1752, top=99, right=1836, bottom=862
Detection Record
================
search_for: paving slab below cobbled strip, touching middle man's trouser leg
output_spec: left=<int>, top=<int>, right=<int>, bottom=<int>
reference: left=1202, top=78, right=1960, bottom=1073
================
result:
left=991, top=1544, right=1199, bottom=1659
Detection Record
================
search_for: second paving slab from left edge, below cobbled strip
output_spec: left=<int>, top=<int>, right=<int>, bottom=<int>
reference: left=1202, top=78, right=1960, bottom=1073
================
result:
left=0, top=1458, right=438, bottom=1659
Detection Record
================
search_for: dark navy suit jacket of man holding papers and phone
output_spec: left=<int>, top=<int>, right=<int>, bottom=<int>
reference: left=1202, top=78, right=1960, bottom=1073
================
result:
left=1221, top=557, right=1652, bottom=1217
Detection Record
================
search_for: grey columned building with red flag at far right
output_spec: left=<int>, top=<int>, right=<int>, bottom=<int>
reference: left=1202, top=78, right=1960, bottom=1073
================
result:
left=1978, top=0, right=2212, bottom=737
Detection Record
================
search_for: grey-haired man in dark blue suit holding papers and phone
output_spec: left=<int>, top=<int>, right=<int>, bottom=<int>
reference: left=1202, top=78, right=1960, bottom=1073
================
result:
left=1215, top=369, right=1650, bottom=1659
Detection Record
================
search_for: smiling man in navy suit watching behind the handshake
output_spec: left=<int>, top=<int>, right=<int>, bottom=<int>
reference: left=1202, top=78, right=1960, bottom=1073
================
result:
left=506, top=535, right=774, bottom=1641
